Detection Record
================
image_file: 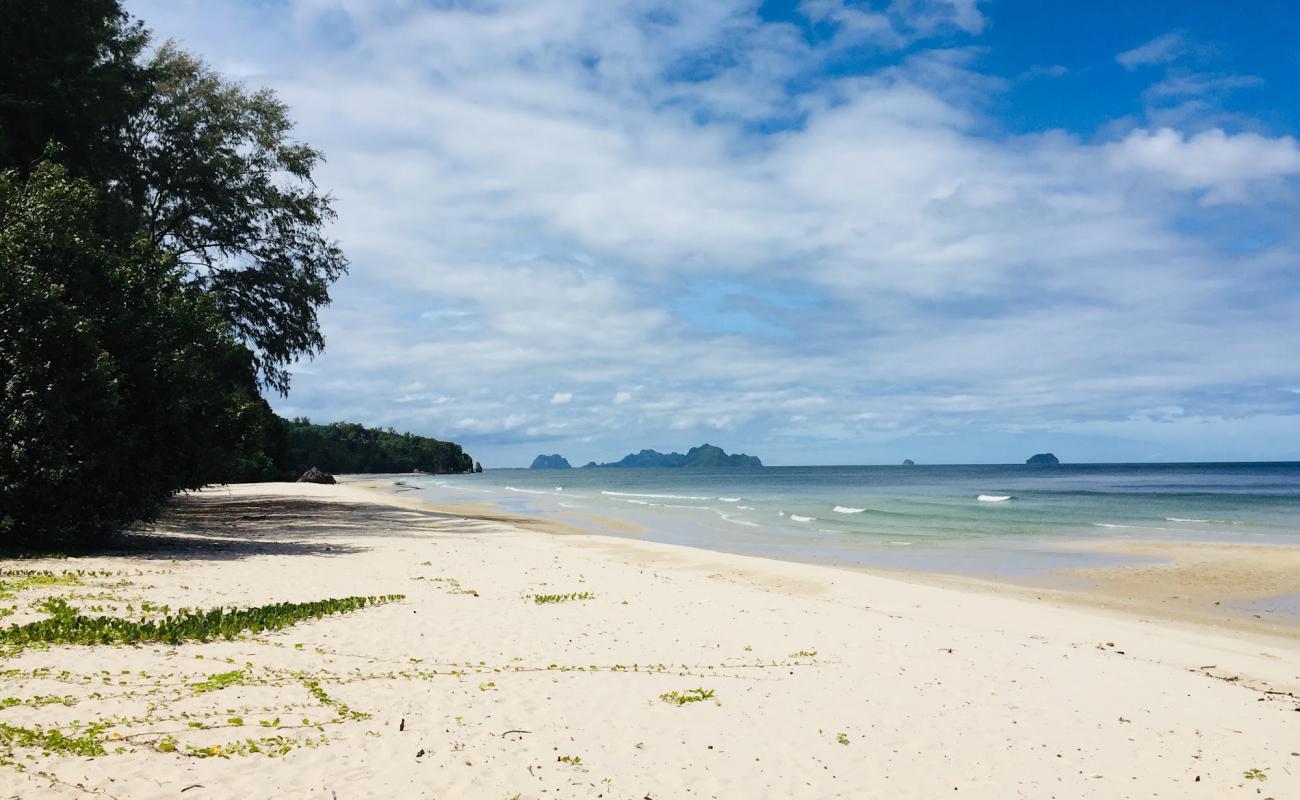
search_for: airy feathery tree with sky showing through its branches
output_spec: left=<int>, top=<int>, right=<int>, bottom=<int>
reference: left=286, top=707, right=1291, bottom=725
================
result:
left=113, top=43, right=347, bottom=393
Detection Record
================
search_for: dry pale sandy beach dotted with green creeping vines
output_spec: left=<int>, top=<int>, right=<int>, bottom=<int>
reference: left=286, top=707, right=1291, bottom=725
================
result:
left=0, top=484, right=1300, bottom=800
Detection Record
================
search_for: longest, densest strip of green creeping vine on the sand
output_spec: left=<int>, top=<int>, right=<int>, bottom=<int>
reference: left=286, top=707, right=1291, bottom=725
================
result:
left=0, top=594, right=404, bottom=650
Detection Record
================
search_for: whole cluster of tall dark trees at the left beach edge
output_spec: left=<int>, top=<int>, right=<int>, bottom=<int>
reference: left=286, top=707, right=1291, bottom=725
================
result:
left=0, top=0, right=464, bottom=546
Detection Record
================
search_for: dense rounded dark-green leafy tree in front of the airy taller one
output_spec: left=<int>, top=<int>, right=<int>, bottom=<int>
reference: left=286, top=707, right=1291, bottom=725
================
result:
left=0, top=163, right=264, bottom=545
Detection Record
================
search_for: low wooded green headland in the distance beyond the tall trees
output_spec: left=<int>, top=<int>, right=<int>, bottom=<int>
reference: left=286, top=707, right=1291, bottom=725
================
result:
left=283, top=419, right=475, bottom=473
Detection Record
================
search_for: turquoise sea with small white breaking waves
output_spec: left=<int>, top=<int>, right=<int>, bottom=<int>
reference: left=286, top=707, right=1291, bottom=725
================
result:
left=391, top=463, right=1300, bottom=575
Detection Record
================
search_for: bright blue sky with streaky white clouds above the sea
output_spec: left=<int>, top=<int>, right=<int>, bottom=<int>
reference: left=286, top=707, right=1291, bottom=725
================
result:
left=126, top=0, right=1300, bottom=467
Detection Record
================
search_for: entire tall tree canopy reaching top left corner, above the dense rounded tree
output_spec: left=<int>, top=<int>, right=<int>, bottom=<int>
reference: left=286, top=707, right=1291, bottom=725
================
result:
left=0, top=0, right=347, bottom=393
